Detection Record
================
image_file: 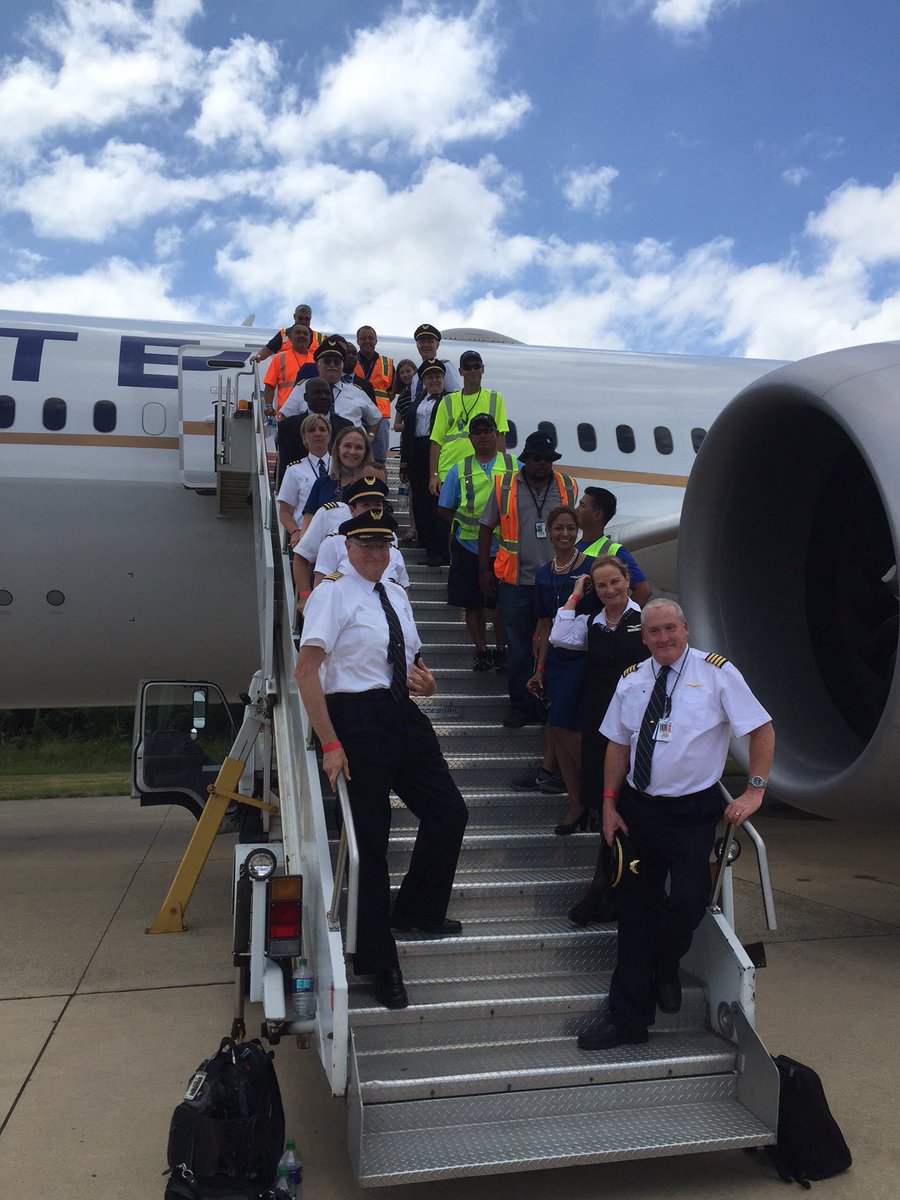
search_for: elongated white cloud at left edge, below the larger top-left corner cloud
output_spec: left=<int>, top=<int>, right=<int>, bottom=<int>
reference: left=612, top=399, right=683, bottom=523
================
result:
left=5, top=140, right=256, bottom=242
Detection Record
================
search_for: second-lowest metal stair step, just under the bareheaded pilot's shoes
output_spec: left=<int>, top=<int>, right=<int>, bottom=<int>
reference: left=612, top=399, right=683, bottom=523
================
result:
left=355, top=1031, right=736, bottom=1105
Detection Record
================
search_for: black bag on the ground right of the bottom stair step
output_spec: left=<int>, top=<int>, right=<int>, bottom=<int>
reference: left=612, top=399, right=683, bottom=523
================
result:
left=766, top=1054, right=852, bottom=1188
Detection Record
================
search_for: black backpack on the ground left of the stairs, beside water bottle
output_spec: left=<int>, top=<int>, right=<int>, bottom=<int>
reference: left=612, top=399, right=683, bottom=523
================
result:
left=166, top=1038, right=284, bottom=1200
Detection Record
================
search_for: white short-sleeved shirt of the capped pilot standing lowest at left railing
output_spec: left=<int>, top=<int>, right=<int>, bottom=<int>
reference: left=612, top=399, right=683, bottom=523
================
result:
left=300, top=566, right=422, bottom=696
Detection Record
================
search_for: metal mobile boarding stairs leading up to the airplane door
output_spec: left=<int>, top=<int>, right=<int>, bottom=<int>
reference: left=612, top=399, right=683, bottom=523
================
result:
left=134, top=347, right=779, bottom=1186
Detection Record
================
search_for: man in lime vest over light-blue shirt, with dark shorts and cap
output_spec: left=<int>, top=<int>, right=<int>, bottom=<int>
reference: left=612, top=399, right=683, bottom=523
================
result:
left=438, top=413, right=518, bottom=671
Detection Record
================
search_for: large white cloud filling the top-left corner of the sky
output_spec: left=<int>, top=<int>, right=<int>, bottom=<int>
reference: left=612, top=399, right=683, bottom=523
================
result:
left=0, top=0, right=202, bottom=157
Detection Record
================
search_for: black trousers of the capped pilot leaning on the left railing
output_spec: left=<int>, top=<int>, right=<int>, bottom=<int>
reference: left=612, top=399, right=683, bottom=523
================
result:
left=325, top=689, right=469, bottom=974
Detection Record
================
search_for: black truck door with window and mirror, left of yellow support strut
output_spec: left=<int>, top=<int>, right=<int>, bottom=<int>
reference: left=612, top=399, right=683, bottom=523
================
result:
left=132, top=679, right=235, bottom=817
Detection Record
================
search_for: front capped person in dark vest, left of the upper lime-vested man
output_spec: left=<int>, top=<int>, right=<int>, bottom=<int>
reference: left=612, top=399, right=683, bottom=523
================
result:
left=400, top=359, right=450, bottom=566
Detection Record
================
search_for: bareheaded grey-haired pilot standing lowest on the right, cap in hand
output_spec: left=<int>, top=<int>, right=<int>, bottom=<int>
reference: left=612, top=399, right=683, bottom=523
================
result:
left=578, top=599, right=775, bottom=1050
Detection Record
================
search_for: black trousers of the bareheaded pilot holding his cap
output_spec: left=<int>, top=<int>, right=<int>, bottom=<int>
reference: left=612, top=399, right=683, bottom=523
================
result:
left=610, top=784, right=722, bottom=1032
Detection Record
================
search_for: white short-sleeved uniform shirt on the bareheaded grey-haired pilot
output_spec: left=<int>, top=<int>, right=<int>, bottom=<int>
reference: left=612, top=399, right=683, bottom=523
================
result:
left=600, top=646, right=772, bottom=796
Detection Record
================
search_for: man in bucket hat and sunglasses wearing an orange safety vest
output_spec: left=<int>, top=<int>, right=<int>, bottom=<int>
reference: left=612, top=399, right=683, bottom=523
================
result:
left=478, top=432, right=578, bottom=728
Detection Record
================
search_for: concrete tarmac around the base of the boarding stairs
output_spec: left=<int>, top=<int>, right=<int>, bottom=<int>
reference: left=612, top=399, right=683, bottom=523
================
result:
left=0, top=798, right=900, bottom=1200
